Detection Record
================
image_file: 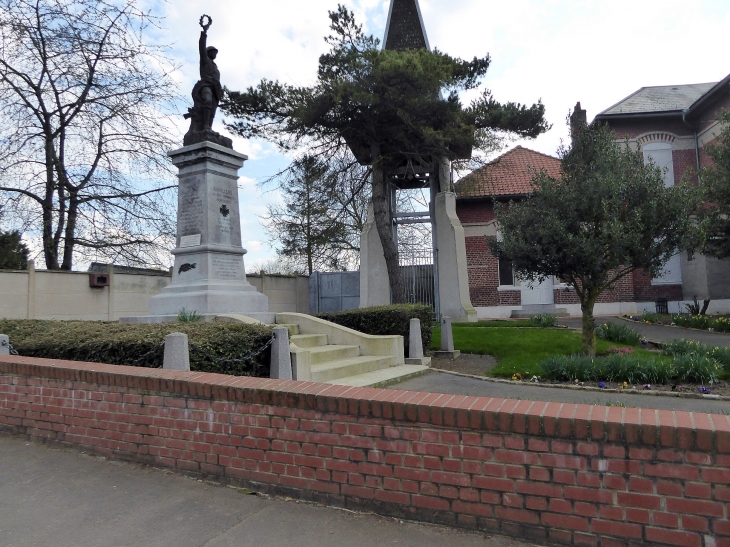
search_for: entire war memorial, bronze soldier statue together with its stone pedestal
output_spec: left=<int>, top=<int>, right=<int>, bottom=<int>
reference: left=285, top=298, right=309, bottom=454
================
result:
left=127, top=15, right=274, bottom=323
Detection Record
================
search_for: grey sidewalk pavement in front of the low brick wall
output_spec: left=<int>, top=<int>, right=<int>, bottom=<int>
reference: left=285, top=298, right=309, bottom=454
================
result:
left=0, top=434, right=533, bottom=547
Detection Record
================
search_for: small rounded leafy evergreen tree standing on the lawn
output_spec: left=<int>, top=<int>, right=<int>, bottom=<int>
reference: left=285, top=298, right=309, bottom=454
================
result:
left=489, top=123, right=697, bottom=355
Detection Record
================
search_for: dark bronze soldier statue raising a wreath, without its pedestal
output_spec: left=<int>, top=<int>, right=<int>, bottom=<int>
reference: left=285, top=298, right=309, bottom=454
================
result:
left=183, top=15, right=233, bottom=148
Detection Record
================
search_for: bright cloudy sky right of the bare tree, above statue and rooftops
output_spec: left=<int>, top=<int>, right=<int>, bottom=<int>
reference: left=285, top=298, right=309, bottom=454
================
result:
left=158, top=0, right=730, bottom=264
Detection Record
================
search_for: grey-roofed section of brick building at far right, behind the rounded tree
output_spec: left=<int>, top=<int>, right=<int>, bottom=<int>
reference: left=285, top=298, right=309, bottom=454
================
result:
left=596, top=75, right=730, bottom=312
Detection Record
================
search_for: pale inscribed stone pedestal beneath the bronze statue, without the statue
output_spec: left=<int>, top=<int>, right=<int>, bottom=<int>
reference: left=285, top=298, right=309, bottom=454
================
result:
left=149, top=142, right=269, bottom=316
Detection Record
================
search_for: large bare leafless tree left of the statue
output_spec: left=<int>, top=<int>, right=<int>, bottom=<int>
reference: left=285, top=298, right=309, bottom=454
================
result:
left=0, top=0, right=178, bottom=270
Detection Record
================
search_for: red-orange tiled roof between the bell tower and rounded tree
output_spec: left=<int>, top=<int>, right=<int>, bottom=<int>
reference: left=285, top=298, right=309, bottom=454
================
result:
left=456, top=146, right=560, bottom=198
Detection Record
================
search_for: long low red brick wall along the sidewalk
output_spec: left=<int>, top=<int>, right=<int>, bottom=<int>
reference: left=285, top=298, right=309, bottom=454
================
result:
left=0, top=356, right=730, bottom=547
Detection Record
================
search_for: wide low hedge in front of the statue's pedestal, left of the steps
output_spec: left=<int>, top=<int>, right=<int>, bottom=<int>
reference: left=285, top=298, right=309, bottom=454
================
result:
left=0, top=319, right=272, bottom=378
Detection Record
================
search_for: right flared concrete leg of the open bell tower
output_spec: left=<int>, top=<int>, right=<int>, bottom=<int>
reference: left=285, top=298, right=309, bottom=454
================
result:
left=434, top=192, right=477, bottom=322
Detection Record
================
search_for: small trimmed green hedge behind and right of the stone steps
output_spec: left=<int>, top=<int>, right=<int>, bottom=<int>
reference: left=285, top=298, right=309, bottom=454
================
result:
left=317, top=304, right=433, bottom=355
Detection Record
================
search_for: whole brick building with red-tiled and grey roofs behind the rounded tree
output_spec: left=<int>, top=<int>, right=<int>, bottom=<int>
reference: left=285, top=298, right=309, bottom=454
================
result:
left=456, top=76, right=730, bottom=317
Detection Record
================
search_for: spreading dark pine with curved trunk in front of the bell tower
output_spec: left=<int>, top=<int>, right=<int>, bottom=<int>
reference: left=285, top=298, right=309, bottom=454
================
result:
left=223, top=6, right=548, bottom=303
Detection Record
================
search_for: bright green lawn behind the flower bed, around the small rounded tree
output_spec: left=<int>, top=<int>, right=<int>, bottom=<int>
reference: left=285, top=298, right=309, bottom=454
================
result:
left=431, top=323, right=668, bottom=378
